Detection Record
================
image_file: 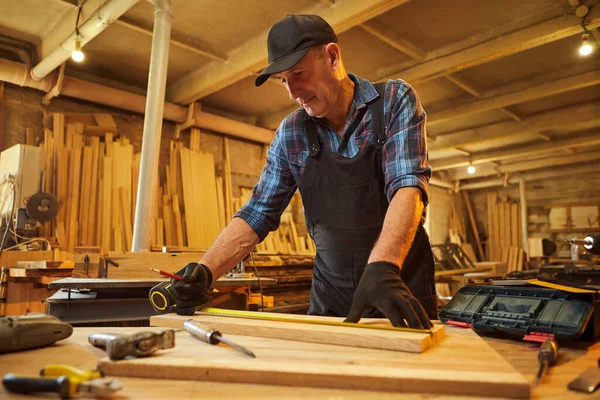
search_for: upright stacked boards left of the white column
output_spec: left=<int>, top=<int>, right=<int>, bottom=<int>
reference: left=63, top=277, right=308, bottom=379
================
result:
left=40, top=113, right=139, bottom=252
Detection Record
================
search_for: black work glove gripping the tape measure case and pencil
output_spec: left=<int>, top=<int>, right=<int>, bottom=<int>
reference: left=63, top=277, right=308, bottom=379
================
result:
left=171, top=263, right=212, bottom=315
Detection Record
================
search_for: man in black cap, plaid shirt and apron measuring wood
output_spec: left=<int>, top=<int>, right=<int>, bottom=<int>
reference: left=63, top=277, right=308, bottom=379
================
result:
left=172, top=15, right=437, bottom=328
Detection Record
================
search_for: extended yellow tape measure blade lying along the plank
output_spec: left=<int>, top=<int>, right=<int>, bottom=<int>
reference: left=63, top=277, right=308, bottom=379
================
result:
left=196, top=307, right=432, bottom=334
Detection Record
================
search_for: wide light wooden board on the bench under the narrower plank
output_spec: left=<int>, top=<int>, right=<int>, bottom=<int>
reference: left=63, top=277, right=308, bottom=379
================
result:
left=92, top=319, right=530, bottom=398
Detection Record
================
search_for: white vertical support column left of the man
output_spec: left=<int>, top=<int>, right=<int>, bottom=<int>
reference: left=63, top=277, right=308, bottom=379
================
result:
left=131, top=0, right=172, bottom=252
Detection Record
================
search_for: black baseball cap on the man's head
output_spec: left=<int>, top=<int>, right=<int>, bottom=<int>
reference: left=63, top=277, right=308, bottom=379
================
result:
left=254, top=14, right=338, bottom=86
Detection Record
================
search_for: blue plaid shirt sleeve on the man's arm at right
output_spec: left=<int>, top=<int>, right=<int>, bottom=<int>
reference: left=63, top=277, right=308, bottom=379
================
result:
left=383, top=80, right=431, bottom=206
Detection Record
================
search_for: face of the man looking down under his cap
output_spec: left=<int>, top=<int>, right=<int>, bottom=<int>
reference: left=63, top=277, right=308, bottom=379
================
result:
left=273, top=48, right=337, bottom=118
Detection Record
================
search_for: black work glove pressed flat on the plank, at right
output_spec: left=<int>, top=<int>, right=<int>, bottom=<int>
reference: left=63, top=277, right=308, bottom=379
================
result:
left=344, top=261, right=433, bottom=329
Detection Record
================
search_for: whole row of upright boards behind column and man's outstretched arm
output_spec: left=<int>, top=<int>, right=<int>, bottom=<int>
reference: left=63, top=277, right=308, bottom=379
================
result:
left=38, top=117, right=315, bottom=254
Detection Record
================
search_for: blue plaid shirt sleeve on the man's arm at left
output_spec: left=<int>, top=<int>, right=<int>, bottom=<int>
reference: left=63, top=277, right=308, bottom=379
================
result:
left=234, top=120, right=296, bottom=242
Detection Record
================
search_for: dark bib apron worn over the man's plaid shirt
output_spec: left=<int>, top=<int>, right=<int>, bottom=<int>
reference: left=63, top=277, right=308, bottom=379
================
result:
left=298, top=84, right=437, bottom=319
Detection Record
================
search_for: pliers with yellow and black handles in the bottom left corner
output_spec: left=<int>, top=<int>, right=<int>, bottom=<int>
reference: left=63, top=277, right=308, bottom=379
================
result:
left=2, top=364, right=121, bottom=399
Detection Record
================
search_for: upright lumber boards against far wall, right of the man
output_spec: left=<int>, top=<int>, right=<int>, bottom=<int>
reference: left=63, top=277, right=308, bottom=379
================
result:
left=487, top=192, right=524, bottom=273
